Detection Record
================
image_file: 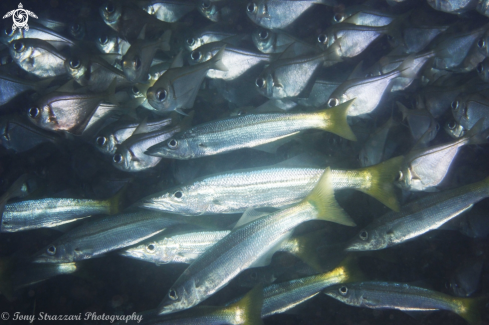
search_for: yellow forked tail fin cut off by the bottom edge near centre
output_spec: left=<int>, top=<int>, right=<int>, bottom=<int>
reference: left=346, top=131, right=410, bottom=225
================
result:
left=226, top=284, right=263, bottom=325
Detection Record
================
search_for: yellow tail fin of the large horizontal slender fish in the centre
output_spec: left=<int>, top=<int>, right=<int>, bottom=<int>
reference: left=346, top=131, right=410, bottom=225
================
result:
left=356, top=156, right=404, bottom=212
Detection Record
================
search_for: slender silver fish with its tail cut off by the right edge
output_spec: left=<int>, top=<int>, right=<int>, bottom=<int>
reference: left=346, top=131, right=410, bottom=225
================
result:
left=346, top=178, right=489, bottom=251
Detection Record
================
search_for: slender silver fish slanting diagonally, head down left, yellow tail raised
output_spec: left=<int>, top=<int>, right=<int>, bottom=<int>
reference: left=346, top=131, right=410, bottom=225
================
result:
left=158, top=169, right=354, bottom=314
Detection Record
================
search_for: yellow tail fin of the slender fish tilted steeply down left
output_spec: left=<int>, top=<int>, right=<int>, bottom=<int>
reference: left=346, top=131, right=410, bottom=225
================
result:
left=303, top=167, right=356, bottom=226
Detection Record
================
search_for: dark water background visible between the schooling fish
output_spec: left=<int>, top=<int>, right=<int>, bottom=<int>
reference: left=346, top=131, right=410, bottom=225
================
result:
left=0, top=0, right=489, bottom=325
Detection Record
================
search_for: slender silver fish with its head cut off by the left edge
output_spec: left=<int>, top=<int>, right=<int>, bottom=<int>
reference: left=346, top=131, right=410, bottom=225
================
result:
left=0, top=195, right=120, bottom=232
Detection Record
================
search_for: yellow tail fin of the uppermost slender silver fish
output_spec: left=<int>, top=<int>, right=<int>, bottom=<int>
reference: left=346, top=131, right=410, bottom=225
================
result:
left=316, top=99, right=357, bottom=141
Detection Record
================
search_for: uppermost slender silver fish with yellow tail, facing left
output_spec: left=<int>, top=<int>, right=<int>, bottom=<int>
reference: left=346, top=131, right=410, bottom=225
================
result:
left=146, top=99, right=356, bottom=159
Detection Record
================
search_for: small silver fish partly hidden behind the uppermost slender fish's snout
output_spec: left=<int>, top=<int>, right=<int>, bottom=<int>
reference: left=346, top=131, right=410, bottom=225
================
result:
left=112, top=126, right=181, bottom=172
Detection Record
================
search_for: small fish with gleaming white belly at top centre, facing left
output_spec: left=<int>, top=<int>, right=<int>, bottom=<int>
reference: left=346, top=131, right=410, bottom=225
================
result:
left=188, top=41, right=273, bottom=80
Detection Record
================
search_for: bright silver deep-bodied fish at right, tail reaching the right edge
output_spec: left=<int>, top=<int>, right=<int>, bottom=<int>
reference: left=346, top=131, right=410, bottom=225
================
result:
left=395, top=120, right=488, bottom=191
